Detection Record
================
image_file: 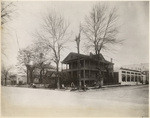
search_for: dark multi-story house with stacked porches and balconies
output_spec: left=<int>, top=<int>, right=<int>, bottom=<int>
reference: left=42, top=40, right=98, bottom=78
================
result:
left=62, top=52, right=114, bottom=86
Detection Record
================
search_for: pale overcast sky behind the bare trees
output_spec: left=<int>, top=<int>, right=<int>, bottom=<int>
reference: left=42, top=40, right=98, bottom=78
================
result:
left=2, top=1, right=149, bottom=67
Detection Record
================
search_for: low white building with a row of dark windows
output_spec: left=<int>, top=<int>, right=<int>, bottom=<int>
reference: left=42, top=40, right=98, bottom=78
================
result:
left=119, top=68, right=146, bottom=85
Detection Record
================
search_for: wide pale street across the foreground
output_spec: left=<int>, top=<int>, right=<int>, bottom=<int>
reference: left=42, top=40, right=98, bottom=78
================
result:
left=2, top=85, right=148, bottom=117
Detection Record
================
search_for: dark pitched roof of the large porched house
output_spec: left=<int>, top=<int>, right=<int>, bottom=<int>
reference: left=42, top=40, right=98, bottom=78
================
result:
left=62, top=52, right=111, bottom=64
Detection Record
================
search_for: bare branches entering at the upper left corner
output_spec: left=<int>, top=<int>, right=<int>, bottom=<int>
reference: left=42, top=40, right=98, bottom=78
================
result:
left=1, top=1, right=15, bottom=25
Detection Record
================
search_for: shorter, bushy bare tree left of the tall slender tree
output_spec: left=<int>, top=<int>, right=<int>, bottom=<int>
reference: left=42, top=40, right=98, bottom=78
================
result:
left=17, top=44, right=50, bottom=83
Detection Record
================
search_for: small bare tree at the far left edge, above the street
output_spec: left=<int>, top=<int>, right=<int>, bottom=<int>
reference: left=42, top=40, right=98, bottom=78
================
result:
left=1, top=66, right=12, bottom=86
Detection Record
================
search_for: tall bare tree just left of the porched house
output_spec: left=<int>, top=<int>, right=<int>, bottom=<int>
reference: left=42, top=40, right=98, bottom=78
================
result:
left=35, top=12, right=69, bottom=89
